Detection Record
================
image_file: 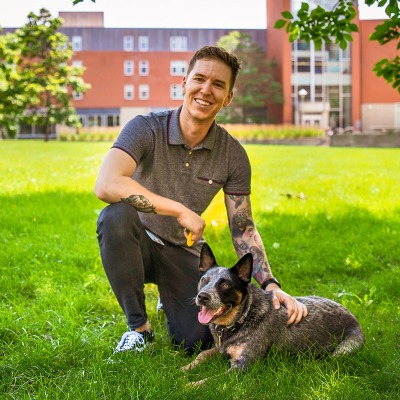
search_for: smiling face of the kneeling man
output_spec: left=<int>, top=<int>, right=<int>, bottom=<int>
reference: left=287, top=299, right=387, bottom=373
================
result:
left=182, top=59, right=233, bottom=122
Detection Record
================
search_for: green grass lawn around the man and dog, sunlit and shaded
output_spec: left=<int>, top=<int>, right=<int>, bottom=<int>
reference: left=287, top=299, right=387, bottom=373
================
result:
left=0, top=141, right=400, bottom=400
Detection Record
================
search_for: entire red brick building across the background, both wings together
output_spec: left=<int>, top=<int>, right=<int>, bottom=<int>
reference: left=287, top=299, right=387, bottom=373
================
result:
left=5, top=0, right=400, bottom=136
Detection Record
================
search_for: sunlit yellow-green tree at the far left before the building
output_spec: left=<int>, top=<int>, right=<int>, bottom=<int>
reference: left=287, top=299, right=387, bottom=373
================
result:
left=0, top=9, right=90, bottom=140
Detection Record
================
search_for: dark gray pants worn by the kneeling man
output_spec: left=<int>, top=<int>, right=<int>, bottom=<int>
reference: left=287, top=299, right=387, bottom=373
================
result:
left=97, top=203, right=212, bottom=351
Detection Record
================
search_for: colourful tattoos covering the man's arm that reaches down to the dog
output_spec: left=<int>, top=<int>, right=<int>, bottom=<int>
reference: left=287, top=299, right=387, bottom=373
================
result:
left=230, top=196, right=271, bottom=283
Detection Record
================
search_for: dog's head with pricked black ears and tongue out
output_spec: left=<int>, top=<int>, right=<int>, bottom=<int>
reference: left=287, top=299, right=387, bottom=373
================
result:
left=196, top=243, right=253, bottom=326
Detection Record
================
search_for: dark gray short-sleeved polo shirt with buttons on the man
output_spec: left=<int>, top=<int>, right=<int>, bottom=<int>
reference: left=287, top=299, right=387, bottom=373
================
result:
left=113, top=107, right=251, bottom=254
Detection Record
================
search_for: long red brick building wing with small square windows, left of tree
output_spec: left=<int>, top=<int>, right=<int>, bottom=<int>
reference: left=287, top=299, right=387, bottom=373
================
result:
left=60, top=12, right=266, bottom=127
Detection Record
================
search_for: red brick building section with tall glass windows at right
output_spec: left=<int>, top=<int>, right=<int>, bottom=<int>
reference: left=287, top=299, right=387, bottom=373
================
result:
left=266, top=0, right=400, bottom=132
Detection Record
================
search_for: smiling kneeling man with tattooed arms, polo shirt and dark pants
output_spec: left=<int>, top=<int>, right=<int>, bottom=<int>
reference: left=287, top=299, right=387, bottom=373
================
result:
left=95, top=46, right=307, bottom=351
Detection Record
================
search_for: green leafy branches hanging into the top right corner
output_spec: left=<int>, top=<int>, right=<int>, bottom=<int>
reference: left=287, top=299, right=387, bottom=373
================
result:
left=274, top=0, right=400, bottom=93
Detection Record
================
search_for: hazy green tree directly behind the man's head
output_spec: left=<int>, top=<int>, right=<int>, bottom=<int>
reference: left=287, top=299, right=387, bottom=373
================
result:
left=217, top=31, right=283, bottom=123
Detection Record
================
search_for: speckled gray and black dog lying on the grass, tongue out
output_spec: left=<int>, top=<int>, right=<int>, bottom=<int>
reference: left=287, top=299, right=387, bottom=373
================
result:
left=182, top=244, right=364, bottom=384
